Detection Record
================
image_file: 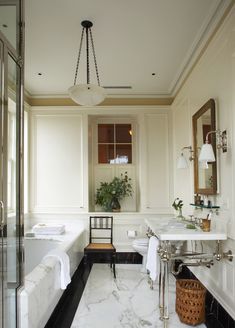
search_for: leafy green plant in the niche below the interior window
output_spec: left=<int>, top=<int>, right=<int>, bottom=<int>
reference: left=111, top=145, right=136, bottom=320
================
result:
left=95, top=172, right=133, bottom=210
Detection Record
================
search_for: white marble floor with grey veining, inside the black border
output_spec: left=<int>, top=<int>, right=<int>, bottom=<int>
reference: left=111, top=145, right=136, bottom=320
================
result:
left=71, top=263, right=206, bottom=328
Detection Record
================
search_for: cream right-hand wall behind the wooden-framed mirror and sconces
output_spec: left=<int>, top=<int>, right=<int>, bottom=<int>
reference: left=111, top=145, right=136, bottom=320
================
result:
left=172, top=8, right=235, bottom=318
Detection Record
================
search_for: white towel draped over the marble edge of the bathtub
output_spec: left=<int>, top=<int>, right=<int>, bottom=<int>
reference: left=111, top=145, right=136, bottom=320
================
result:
left=44, top=248, right=71, bottom=289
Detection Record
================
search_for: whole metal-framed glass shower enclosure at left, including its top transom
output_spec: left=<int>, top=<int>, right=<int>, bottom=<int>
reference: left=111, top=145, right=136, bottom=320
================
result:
left=0, top=0, right=23, bottom=328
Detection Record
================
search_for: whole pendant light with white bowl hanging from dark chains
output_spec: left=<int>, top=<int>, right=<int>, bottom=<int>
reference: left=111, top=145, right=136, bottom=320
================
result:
left=68, top=20, right=106, bottom=106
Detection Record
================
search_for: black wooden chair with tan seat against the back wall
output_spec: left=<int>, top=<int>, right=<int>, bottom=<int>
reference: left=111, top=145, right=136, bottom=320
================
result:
left=84, top=216, right=116, bottom=278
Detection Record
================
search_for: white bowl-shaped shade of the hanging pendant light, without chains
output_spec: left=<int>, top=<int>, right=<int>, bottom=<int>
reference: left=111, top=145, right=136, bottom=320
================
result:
left=68, top=84, right=106, bottom=106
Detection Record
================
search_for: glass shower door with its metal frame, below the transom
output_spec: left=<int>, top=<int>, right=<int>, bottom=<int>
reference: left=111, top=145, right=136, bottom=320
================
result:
left=0, top=45, right=23, bottom=328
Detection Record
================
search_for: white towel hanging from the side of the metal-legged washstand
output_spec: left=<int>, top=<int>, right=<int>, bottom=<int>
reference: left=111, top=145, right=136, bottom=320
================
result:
left=146, top=236, right=159, bottom=281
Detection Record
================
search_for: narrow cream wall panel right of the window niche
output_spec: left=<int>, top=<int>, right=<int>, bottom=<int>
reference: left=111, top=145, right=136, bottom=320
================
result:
left=141, top=113, right=170, bottom=211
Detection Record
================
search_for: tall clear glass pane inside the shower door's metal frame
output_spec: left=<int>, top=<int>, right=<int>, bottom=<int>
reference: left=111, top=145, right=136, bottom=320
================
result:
left=3, top=53, right=22, bottom=328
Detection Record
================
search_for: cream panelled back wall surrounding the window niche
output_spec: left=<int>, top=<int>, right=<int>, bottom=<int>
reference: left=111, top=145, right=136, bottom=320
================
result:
left=27, top=106, right=173, bottom=251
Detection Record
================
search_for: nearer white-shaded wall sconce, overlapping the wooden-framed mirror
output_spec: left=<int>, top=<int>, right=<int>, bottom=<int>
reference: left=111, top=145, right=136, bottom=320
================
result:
left=198, top=130, right=228, bottom=162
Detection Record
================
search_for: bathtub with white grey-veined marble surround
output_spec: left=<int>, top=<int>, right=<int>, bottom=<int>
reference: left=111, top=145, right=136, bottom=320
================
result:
left=19, top=226, right=85, bottom=328
